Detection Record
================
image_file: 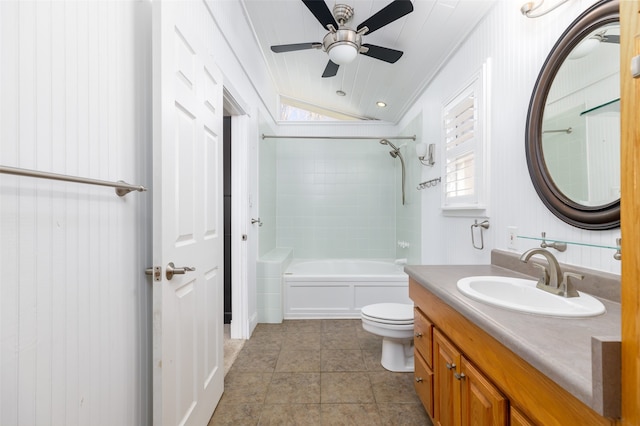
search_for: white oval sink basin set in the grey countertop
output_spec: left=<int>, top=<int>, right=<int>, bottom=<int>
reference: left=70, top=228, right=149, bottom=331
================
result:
left=458, top=276, right=606, bottom=317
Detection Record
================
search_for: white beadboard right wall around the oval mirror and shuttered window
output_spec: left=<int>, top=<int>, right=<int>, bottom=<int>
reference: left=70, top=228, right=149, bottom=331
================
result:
left=401, top=0, right=620, bottom=273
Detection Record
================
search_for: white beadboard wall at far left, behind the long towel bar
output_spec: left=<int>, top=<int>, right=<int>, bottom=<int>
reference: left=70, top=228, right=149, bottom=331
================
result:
left=0, top=1, right=151, bottom=425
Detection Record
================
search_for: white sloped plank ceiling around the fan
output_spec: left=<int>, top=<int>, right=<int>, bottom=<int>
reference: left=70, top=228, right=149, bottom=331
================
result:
left=243, top=0, right=495, bottom=123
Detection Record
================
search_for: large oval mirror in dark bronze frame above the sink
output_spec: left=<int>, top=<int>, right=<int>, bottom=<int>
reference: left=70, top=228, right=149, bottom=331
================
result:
left=525, top=0, right=620, bottom=230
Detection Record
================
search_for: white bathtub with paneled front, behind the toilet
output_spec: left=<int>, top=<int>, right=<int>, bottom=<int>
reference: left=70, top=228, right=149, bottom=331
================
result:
left=282, top=259, right=412, bottom=319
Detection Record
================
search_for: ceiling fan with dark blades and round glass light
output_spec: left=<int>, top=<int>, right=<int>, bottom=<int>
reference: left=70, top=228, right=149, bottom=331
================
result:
left=271, top=0, right=413, bottom=77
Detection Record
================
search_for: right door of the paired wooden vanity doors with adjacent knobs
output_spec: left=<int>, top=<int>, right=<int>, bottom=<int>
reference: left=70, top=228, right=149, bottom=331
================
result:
left=458, top=356, right=509, bottom=426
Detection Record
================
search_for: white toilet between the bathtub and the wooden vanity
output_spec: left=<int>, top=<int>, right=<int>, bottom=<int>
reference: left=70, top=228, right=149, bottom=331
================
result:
left=360, top=303, right=413, bottom=372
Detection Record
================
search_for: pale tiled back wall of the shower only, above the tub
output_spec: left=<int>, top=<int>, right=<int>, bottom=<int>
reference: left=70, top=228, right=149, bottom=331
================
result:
left=276, top=139, right=400, bottom=258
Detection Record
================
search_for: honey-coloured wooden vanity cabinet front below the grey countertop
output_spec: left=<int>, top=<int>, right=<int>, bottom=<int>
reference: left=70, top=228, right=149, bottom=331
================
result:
left=409, top=278, right=619, bottom=426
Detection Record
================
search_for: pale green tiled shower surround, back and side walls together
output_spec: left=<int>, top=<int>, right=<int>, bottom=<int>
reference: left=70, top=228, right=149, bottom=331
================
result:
left=258, top=115, right=424, bottom=263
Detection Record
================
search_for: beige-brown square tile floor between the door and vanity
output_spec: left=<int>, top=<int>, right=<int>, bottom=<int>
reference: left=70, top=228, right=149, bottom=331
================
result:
left=209, top=320, right=431, bottom=426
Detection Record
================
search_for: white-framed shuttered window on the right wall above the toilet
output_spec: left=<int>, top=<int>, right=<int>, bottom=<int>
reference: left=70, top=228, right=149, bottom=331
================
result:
left=442, top=62, right=488, bottom=210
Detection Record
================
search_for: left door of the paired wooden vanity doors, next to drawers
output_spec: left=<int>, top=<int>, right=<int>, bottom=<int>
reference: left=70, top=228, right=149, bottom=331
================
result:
left=433, top=329, right=460, bottom=426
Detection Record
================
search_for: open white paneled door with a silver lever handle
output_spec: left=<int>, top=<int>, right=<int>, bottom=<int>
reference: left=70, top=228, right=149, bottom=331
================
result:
left=152, top=1, right=224, bottom=425
